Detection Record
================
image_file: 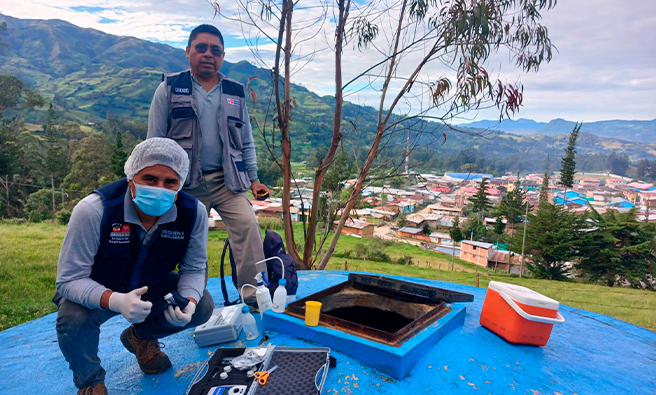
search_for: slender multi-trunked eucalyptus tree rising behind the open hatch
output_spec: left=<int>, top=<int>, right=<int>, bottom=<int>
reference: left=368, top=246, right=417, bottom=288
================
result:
left=222, top=0, right=556, bottom=269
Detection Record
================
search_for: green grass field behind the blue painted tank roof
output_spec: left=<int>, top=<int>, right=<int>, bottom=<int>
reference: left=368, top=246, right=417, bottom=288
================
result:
left=0, top=222, right=656, bottom=331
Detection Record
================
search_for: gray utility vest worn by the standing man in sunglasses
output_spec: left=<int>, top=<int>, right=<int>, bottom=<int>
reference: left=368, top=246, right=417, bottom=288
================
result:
left=165, top=70, right=251, bottom=193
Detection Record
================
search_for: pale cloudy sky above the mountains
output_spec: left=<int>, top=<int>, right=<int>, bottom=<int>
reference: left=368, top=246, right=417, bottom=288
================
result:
left=0, top=0, right=656, bottom=123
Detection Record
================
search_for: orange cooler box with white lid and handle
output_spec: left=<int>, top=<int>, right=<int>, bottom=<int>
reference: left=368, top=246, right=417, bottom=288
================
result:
left=481, top=281, right=565, bottom=346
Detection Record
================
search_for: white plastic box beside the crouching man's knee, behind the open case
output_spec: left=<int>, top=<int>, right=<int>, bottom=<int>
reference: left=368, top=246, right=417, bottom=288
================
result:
left=194, top=304, right=243, bottom=347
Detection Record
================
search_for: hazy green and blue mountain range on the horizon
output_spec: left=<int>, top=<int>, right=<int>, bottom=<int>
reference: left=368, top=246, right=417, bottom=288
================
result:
left=0, top=15, right=656, bottom=171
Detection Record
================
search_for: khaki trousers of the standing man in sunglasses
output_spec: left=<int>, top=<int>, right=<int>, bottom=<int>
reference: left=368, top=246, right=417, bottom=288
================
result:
left=184, top=170, right=266, bottom=302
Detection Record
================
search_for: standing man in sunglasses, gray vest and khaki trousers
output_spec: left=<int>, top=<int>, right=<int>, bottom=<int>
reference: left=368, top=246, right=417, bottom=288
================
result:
left=148, top=25, right=269, bottom=303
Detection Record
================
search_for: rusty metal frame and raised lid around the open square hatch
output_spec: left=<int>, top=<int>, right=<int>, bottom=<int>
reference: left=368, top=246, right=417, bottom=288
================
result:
left=285, top=273, right=474, bottom=347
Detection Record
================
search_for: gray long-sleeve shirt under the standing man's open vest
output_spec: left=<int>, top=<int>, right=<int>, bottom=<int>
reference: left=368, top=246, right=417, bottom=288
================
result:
left=148, top=73, right=257, bottom=181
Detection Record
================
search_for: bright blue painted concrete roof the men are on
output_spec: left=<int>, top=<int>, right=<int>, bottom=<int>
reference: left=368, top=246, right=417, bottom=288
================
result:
left=0, top=271, right=656, bottom=395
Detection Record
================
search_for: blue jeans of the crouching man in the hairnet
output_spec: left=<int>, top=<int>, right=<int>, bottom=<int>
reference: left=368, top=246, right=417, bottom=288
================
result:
left=53, top=273, right=214, bottom=388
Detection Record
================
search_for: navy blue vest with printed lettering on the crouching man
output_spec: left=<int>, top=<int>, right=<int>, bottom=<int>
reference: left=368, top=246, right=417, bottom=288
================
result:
left=91, top=178, right=198, bottom=292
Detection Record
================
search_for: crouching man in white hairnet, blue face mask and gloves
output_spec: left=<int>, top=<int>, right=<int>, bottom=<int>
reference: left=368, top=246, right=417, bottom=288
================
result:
left=53, top=138, right=214, bottom=395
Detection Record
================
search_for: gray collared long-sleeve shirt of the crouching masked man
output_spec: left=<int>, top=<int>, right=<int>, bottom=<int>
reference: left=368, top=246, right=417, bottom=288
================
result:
left=56, top=190, right=208, bottom=309
